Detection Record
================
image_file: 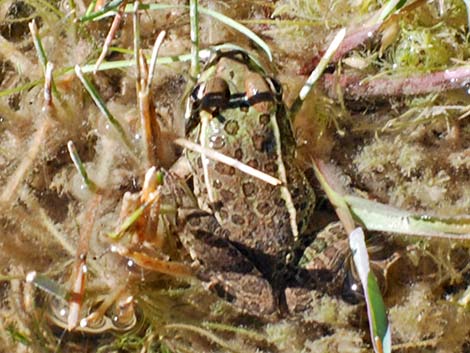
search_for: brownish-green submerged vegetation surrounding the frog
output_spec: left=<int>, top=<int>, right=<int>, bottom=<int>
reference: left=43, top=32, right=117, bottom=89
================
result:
left=0, top=0, right=470, bottom=353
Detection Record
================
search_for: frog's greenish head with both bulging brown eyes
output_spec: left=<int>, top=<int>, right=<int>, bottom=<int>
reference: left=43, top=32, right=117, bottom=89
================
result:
left=187, top=50, right=282, bottom=130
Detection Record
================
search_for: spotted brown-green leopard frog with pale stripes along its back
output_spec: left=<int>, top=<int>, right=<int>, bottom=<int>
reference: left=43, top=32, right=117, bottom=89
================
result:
left=167, top=51, right=315, bottom=316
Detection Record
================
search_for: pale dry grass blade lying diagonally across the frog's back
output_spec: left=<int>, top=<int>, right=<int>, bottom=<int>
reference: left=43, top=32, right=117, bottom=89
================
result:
left=173, top=138, right=282, bottom=186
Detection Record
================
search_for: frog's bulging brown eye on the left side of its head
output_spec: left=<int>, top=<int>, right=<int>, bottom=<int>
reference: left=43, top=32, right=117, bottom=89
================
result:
left=195, top=76, right=230, bottom=113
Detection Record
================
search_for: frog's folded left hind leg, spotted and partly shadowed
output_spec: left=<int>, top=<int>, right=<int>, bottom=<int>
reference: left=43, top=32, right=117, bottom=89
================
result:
left=178, top=208, right=278, bottom=318
